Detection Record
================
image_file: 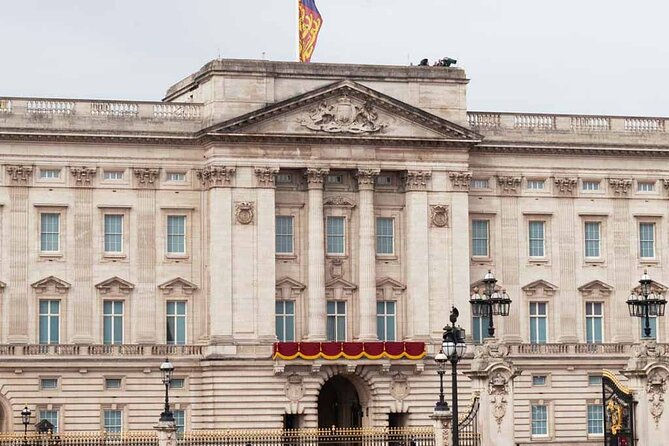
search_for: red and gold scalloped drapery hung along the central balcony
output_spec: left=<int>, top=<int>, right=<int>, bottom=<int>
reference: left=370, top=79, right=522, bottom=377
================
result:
left=272, top=342, right=425, bottom=360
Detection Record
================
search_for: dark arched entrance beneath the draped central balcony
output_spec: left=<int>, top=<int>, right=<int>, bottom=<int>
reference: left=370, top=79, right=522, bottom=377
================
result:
left=318, top=375, right=362, bottom=428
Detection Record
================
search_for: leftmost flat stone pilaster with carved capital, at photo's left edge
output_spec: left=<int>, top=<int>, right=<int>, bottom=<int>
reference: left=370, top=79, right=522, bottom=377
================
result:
left=6, top=166, right=32, bottom=344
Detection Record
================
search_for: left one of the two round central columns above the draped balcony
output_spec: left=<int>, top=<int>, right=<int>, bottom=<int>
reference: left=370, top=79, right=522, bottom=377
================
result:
left=305, top=168, right=330, bottom=341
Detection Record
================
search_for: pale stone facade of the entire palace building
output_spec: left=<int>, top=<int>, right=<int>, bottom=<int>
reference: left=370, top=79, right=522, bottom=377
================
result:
left=0, top=60, right=669, bottom=445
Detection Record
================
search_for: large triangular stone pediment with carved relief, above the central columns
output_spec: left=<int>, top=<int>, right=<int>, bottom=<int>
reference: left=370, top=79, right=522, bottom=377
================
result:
left=203, top=80, right=482, bottom=143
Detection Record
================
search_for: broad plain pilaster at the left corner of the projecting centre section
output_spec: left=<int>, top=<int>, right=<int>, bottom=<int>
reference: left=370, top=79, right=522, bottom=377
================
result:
left=197, top=166, right=235, bottom=345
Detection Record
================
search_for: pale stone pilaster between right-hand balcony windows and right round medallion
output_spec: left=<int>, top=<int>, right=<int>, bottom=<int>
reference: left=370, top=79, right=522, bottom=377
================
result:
left=404, top=170, right=432, bottom=340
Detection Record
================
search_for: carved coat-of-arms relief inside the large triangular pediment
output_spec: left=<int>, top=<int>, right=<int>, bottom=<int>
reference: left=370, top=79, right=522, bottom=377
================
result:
left=297, top=96, right=388, bottom=134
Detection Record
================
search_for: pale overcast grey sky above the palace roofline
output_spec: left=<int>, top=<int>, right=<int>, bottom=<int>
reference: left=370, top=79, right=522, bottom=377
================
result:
left=0, top=0, right=669, bottom=116
